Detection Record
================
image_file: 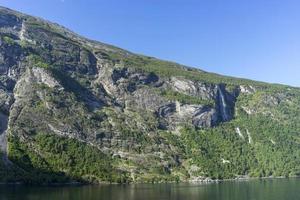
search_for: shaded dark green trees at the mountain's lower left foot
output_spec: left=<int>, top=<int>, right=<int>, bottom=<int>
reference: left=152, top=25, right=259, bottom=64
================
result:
left=9, top=134, right=130, bottom=184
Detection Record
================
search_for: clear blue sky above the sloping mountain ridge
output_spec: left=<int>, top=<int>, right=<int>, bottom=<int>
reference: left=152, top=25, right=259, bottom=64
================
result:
left=0, top=0, right=300, bottom=86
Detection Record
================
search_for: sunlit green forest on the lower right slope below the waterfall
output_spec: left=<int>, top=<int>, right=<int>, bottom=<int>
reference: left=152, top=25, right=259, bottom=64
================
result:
left=178, top=115, right=300, bottom=179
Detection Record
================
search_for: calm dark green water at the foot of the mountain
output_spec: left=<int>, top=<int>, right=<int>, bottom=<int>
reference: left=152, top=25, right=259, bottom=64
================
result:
left=0, top=179, right=300, bottom=200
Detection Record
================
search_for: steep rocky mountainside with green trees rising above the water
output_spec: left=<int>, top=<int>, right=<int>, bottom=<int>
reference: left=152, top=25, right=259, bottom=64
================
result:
left=0, top=7, right=300, bottom=184
